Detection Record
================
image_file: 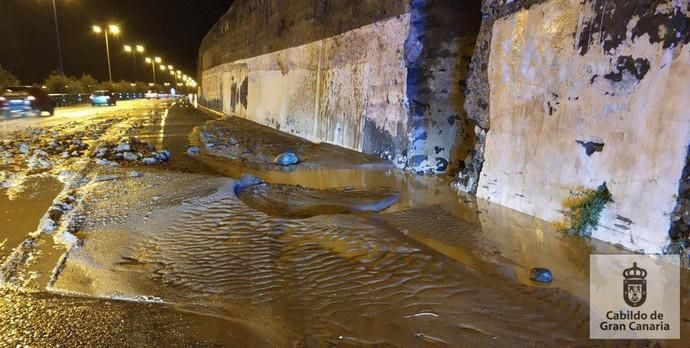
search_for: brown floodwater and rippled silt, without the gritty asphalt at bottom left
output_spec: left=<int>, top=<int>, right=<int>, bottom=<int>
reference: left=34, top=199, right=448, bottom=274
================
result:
left=26, top=100, right=688, bottom=347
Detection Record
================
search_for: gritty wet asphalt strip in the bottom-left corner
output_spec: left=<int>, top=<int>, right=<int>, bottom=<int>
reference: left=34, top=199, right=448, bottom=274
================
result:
left=0, top=289, right=267, bottom=347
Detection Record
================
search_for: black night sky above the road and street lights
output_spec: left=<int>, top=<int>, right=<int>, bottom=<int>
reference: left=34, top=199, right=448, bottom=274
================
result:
left=0, top=0, right=233, bottom=84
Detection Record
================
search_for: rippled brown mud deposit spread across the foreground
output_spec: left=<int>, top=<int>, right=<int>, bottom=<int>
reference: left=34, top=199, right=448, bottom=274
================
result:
left=54, top=178, right=586, bottom=346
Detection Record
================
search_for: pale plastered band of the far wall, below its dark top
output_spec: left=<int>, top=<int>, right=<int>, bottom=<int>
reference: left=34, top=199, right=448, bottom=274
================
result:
left=201, top=15, right=409, bottom=151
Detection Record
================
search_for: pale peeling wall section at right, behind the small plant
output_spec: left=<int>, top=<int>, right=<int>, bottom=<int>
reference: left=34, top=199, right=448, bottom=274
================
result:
left=460, top=0, right=690, bottom=252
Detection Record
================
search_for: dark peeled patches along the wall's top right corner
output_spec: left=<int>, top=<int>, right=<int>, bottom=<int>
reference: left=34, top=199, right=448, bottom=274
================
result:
left=577, top=0, right=690, bottom=55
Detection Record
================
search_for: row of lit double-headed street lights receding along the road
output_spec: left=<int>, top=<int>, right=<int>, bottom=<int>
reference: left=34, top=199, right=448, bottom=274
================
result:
left=92, top=24, right=197, bottom=88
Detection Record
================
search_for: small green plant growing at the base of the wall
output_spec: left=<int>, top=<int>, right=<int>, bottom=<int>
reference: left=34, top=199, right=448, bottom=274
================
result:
left=561, top=183, right=613, bottom=236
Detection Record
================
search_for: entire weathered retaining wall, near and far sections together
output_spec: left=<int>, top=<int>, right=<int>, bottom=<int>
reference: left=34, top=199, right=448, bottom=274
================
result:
left=199, top=0, right=690, bottom=252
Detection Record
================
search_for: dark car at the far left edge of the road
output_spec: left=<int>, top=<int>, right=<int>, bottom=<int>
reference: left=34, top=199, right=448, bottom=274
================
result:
left=0, top=86, right=55, bottom=116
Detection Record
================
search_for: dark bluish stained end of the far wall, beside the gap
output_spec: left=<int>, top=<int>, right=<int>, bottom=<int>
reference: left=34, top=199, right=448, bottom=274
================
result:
left=404, top=0, right=481, bottom=173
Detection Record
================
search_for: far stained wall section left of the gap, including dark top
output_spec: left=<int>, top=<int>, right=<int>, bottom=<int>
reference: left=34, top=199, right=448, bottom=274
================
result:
left=199, top=0, right=480, bottom=173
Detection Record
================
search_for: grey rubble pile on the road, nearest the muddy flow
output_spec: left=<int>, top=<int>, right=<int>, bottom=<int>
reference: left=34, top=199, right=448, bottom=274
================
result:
left=93, top=137, right=171, bottom=166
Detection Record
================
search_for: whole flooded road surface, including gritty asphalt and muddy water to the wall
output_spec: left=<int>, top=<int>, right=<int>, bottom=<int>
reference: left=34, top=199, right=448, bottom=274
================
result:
left=0, top=102, right=690, bottom=347
